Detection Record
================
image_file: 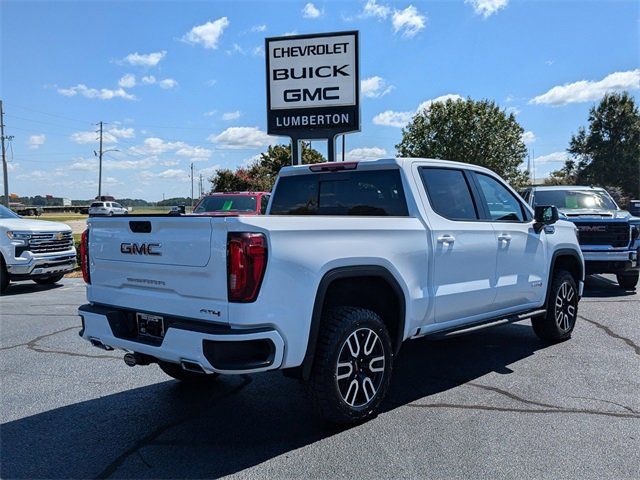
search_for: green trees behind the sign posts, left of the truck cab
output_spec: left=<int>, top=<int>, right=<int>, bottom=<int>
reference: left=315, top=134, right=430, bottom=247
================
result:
left=209, top=142, right=325, bottom=192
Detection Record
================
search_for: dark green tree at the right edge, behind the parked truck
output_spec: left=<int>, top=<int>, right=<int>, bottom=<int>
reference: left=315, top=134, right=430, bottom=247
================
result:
left=562, top=92, right=640, bottom=198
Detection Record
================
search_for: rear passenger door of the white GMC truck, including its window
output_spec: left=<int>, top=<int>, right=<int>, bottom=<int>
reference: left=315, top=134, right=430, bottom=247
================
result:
left=418, top=166, right=497, bottom=323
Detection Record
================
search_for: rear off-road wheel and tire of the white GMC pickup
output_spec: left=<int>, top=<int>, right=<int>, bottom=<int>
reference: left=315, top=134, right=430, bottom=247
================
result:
left=307, top=307, right=393, bottom=424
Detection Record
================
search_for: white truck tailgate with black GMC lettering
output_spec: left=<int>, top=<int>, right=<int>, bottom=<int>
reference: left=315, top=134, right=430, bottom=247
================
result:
left=87, top=216, right=227, bottom=323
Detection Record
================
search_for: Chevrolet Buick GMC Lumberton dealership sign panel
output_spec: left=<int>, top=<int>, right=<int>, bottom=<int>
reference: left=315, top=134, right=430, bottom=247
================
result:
left=265, top=31, right=360, bottom=140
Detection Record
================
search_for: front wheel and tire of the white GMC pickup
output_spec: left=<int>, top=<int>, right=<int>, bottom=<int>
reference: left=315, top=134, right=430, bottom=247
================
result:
left=531, top=270, right=578, bottom=342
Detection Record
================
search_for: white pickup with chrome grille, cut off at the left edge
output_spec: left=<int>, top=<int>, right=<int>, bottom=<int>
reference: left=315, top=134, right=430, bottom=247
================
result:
left=0, top=205, right=76, bottom=293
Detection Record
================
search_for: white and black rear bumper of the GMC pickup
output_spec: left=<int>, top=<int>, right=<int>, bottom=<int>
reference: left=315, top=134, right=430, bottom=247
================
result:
left=78, top=305, right=284, bottom=374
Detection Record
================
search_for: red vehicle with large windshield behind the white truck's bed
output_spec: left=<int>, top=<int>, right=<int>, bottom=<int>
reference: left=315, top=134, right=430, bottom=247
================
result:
left=193, top=192, right=271, bottom=216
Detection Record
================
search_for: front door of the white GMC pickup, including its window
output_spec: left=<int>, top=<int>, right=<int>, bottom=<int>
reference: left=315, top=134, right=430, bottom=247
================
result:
left=470, top=172, right=548, bottom=309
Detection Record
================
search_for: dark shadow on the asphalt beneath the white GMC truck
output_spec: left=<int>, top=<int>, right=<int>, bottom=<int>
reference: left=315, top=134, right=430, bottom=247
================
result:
left=0, top=324, right=544, bottom=478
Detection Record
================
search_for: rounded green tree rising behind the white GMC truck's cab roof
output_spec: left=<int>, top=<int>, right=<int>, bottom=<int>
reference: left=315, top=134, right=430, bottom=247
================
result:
left=396, top=98, right=528, bottom=187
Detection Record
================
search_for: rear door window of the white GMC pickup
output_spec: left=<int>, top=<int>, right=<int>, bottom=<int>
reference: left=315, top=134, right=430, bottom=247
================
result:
left=420, top=167, right=478, bottom=220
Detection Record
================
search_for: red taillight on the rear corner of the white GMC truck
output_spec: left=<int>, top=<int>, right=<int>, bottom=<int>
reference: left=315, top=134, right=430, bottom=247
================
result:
left=227, top=233, right=267, bottom=302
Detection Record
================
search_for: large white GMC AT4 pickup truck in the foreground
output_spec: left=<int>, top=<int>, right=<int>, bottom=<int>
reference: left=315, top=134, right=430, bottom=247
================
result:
left=79, top=159, right=584, bottom=423
